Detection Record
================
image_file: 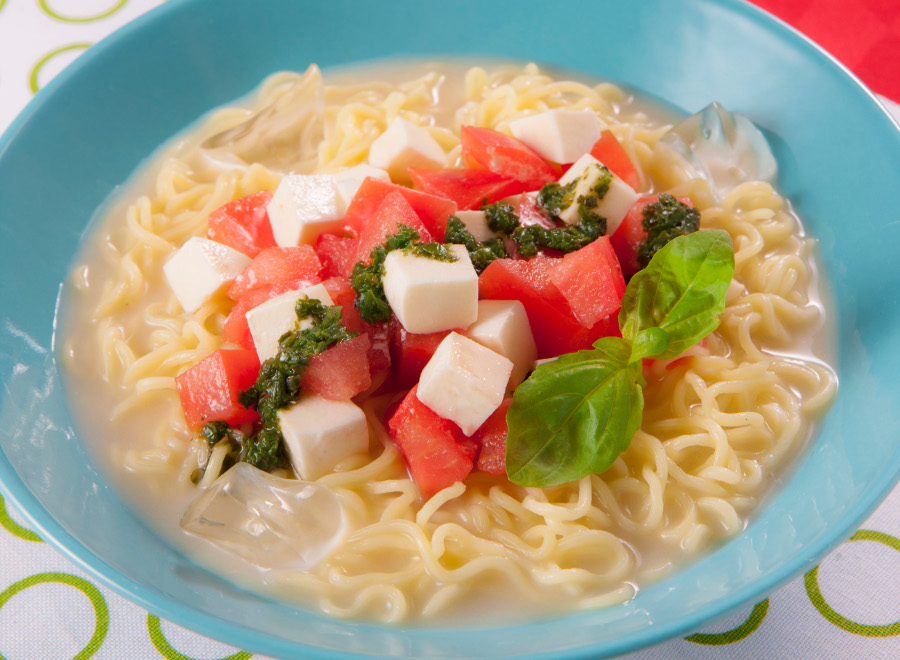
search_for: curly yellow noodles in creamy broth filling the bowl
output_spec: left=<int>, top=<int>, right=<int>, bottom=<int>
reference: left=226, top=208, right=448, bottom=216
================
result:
left=58, top=64, right=836, bottom=622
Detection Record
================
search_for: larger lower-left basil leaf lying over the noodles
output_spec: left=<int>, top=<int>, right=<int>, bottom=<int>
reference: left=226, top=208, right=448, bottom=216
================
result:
left=506, top=337, right=644, bottom=487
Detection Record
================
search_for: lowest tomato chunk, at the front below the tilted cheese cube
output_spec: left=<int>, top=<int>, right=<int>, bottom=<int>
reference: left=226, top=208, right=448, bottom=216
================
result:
left=388, top=386, right=473, bottom=496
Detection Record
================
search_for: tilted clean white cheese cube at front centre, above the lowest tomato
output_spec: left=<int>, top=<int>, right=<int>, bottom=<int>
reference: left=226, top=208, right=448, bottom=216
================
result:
left=416, top=332, right=513, bottom=436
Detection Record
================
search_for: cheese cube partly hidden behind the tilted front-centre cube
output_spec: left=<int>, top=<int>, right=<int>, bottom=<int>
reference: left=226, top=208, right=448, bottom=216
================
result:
left=466, top=300, right=537, bottom=389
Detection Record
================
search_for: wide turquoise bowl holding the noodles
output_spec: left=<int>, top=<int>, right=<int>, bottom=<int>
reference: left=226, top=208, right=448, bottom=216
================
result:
left=0, top=0, right=900, bottom=658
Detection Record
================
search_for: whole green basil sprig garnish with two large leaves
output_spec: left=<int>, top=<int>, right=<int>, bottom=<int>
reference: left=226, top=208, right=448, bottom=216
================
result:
left=506, top=229, right=734, bottom=487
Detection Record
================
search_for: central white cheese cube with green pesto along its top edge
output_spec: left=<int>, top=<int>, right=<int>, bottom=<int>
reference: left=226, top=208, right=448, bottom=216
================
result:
left=383, top=245, right=478, bottom=333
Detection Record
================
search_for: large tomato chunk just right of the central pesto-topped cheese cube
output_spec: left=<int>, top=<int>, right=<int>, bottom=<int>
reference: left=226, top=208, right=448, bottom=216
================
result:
left=478, top=256, right=619, bottom=358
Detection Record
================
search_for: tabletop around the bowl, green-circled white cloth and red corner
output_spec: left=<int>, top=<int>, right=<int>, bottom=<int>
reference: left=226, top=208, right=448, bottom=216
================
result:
left=0, top=0, right=900, bottom=660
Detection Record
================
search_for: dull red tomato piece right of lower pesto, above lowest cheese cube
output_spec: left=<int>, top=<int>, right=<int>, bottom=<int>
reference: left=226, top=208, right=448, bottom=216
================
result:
left=302, top=334, right=372, bottom=401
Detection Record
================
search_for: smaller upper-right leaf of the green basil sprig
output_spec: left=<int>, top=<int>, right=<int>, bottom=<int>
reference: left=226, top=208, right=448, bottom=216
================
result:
left=619, top=229, right=734, bottom=360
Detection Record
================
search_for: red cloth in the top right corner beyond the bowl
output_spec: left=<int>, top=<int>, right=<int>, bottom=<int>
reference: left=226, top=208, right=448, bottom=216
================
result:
left=753, top=0, right=900, bottom=102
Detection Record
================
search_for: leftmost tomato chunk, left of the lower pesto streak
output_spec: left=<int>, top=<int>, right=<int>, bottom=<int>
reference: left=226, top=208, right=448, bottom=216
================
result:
left=175, top=348, right=259, bottom=430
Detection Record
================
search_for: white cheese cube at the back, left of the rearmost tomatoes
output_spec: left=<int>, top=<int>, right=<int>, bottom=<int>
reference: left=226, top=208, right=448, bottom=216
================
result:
left=369, top=117, right=447, bottom=183
